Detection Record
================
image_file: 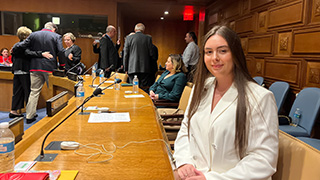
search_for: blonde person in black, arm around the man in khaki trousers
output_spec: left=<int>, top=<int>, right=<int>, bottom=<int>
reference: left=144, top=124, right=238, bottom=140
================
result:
left=9, top=26, right=52, bottom=118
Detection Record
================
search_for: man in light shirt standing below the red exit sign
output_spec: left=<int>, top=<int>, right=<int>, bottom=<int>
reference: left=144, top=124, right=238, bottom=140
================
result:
left=182, top=32, right=200, bottom=82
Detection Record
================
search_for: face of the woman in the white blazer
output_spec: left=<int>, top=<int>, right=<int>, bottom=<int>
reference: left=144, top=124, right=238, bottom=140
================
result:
left=204, top=35, right=233, bottom=78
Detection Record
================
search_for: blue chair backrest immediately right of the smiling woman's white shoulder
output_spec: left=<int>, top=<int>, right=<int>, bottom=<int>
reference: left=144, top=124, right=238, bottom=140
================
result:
left=269, top=81, right=289, bottom=113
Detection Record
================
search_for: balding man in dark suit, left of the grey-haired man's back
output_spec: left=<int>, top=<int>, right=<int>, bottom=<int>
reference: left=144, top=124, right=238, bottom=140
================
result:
left=99, top=25, right=119, bottom=77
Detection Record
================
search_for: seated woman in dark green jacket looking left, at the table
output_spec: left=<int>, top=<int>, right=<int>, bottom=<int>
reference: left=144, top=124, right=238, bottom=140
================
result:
left=149, top=54, right=187, bottom=102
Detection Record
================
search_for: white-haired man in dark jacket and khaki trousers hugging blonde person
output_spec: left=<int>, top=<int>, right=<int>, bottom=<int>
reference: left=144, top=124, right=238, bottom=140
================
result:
left=13, top=22, right=66, bottom=123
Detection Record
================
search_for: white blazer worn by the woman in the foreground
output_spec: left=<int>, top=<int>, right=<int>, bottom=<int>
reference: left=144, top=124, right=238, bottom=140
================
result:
left=174, top=77, right=279, bottom=180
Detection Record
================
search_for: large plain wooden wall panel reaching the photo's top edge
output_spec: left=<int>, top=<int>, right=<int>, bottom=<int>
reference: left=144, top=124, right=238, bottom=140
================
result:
left=268, top=1, right=304, bottom=28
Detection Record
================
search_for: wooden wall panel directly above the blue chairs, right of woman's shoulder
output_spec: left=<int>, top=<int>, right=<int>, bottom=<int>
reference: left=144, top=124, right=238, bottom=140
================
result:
left=264, top=58, right=302, bottom=87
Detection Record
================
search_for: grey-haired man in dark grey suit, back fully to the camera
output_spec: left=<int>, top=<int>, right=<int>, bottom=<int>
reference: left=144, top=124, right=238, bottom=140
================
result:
left=123, top=23, right=154, bottom=90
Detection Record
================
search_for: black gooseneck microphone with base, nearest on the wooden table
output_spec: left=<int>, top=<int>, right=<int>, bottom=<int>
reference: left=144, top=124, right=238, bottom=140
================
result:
left=35, top=80, right=117, bottom=162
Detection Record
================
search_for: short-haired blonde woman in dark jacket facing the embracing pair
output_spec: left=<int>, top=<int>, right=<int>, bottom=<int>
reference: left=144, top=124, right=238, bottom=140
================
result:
left=63, top=32, right=83, bottom=74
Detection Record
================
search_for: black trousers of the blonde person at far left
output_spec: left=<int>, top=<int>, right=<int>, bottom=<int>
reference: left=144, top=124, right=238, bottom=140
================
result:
left=11, top=74, right=30, bottom=110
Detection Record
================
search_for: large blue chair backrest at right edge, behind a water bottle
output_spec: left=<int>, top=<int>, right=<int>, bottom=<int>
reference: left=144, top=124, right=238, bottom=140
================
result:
left=289, top=88, right=320, bottom=136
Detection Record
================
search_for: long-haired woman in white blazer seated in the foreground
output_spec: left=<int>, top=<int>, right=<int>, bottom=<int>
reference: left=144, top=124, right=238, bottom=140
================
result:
left=174, top=26, right=278, bottom=180
